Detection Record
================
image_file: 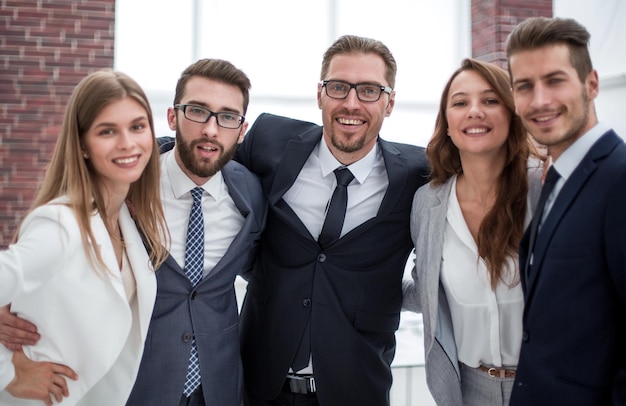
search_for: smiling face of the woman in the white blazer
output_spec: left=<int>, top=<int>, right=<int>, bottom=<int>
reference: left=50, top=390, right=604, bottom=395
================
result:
left=81, top=97, right=154, bottom=196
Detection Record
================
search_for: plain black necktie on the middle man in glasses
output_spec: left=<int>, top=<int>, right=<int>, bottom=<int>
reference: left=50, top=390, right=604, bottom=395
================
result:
left=317, top=167, right=354, bottom=248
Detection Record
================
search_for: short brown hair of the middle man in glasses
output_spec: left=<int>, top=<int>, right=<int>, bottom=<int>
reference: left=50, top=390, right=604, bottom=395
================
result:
left=320, top=35, right=398, bottom=89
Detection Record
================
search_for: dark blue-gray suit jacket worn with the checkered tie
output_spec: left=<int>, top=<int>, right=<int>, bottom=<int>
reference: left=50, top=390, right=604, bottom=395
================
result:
left=127, top=139, right=267, bottom=406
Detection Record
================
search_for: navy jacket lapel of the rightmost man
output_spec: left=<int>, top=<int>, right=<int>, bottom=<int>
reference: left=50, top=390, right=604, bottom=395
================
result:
left=525, top=131, right=621, bottom=299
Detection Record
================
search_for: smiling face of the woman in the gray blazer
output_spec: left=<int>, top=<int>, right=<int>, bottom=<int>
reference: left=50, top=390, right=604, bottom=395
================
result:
left=446, top=70, right=512, bottom=159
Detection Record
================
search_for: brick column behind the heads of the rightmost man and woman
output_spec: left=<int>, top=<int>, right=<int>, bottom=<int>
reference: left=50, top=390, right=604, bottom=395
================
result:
left=472, top=0, right=552, bottom=68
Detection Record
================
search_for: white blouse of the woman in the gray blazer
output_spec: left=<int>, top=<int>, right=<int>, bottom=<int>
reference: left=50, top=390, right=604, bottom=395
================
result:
left=441, top=178, right=530, bottom=368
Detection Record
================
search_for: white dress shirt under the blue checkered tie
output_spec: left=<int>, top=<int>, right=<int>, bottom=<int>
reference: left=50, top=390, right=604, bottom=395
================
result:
left=161, top=147, right=244, bottom=276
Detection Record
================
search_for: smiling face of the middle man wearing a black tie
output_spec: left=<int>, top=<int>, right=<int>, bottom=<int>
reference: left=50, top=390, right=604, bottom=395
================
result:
left=317, top=54, right=395, bottom=165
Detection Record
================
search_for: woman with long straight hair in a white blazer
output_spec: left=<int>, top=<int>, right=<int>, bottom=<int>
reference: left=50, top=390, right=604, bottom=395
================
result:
left=0, top=70, right=167, bottom=406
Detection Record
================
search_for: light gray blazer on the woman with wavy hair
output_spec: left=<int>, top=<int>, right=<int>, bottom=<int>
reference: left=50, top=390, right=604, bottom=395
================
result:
left=402, top=161, right=541, bottom=406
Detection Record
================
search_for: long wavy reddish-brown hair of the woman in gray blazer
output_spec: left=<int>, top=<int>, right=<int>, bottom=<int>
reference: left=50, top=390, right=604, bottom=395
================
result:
left=426, top=58, right=535, bottom=290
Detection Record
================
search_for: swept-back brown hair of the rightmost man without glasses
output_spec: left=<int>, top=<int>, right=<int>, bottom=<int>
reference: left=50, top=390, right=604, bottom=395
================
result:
left=506, top=17, right=593, bottom=83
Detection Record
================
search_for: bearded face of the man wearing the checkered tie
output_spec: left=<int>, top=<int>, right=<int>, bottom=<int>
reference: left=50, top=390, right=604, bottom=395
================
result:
left=167, top=76, right=248, bottom=185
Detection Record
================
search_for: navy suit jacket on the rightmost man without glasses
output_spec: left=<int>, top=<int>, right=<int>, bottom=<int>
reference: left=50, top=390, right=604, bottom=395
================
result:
left=511, top=131, right=626, bottom=406
